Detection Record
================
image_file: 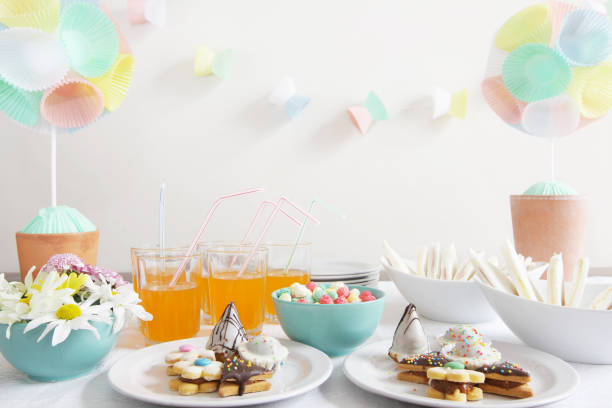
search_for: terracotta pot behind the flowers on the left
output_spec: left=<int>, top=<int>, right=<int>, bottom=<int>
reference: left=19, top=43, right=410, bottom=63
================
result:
left=15, top=230, right=100, bottom=281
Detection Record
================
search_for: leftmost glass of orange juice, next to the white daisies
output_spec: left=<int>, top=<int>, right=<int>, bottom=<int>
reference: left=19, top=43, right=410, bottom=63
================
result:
left=134, top=250, right=203, bottom=343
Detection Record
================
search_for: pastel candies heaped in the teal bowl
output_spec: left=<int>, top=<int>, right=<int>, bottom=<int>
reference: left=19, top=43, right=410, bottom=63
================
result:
left=277, top=281, right=376, bottom=305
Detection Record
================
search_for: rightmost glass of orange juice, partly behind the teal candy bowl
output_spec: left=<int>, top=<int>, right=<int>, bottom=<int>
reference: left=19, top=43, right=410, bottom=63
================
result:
left=265, top=242, right=312, bottom=323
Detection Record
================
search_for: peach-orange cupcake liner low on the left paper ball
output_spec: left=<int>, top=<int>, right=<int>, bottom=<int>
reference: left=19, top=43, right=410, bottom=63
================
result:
left=40, top=73, right=104, bottom=128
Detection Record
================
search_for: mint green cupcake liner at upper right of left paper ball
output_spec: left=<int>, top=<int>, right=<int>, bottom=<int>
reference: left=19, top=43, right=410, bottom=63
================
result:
left=59, top=3, right=119, bottom=78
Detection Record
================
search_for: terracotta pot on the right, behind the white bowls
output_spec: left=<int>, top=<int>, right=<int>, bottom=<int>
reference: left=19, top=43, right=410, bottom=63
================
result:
left=510, top=195, right=589, bottom=280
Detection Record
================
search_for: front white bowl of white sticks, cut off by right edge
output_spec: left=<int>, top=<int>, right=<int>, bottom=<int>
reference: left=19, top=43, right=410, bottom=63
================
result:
left=479, top=283, right=612, bottom=364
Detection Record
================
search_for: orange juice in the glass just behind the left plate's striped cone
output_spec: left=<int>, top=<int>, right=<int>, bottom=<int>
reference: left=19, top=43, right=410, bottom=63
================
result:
left=210, top=270, right=266, bottom=334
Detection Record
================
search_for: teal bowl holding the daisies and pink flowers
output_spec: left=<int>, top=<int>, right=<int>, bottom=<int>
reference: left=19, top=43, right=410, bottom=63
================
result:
left=0, top=322, right=119, bottom=382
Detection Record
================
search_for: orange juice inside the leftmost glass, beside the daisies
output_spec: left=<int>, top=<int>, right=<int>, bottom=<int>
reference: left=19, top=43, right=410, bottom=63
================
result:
left=138, top=282, right=201, bottom=342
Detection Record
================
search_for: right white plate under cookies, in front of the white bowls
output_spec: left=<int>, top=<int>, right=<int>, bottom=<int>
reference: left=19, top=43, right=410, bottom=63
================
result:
left=344, top=339, right=580, bottom=408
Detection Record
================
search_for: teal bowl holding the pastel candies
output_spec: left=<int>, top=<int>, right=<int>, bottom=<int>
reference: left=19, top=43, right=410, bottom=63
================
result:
left=271, top=285, right=385, bottom=357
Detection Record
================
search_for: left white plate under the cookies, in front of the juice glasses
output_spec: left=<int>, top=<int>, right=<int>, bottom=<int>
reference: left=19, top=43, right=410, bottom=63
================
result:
left=108, top=337, right=332, bottom=407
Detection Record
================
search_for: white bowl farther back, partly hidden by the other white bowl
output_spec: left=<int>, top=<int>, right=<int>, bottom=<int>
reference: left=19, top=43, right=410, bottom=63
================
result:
left=381, top=257, right=496, bottom=323
